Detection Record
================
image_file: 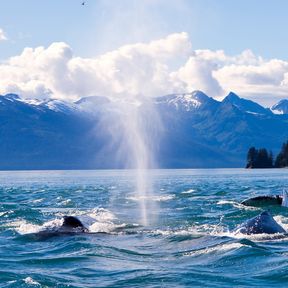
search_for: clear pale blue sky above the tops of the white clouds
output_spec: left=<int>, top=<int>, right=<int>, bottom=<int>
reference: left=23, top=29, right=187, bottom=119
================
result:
left=0, top=0, right=288, bottom=59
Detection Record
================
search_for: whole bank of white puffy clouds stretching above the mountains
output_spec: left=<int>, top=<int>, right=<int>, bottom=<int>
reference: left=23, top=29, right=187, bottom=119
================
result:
left=0, top=30, right=288, bottom=105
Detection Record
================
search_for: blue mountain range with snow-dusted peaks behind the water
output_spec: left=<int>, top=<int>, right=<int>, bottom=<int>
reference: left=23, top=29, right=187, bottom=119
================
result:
left=0, top=91, right=288, bottom=170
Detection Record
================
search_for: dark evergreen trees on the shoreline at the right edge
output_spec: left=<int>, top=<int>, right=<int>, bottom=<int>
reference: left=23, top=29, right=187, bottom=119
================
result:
left=246, top=141, right=288, bottom=168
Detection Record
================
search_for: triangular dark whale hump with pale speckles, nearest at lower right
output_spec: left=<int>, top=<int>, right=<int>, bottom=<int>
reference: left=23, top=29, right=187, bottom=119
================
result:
left=235, top=211, right=286, bottom=235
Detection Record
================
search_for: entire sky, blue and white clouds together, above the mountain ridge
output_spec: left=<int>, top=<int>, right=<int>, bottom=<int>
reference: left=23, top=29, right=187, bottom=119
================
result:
left=0, top=0, right=288, bottom=106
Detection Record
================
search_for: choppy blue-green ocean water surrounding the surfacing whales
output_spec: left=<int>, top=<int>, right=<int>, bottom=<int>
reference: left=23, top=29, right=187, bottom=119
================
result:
left=0, top=169, right=288, bottom=287
